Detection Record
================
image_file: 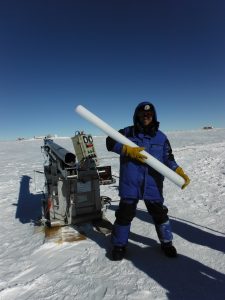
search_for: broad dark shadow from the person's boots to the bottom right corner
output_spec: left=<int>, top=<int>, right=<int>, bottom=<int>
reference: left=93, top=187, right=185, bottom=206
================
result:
left=127, top=239, right=225, bottom=300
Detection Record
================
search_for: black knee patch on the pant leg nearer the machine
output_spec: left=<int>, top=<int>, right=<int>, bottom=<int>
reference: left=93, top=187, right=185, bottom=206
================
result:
left=115, top=201, right=137, bottom=225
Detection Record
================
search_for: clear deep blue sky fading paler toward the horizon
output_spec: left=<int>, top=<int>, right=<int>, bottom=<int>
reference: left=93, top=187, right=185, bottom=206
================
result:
left=0, top=0, right=225, bottom=140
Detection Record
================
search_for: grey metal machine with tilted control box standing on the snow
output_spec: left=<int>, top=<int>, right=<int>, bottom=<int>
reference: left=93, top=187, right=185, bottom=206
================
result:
left=41, top=131, right=115, bottom=227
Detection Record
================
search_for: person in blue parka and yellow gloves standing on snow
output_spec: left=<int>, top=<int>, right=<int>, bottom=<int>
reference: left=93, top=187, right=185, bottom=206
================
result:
left=106, top=102, right=190, bottom=260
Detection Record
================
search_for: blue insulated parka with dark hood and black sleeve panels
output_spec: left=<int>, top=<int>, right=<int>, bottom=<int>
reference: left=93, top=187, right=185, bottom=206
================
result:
left=106, top=102, right=178, bottom=202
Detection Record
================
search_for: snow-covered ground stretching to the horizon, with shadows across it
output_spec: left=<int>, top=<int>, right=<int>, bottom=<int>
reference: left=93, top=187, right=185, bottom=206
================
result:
left=0, top=129, right=225, bottom=300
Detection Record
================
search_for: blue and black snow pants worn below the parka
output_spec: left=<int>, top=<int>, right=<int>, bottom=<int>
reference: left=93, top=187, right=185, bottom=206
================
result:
left=112, top=198, right=173, bottom=246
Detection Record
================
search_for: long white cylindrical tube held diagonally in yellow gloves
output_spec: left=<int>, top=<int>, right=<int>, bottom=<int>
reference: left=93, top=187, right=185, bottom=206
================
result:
left=75, top=105, right=185, bottom=187
